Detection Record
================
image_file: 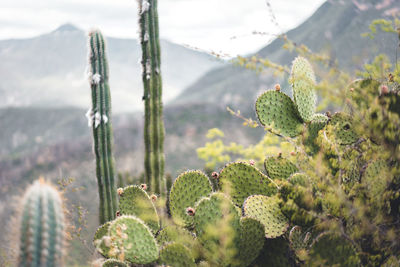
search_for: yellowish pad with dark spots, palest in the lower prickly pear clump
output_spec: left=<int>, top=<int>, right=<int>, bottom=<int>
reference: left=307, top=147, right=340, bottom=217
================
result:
left=243, top=195, right=289, bottom=238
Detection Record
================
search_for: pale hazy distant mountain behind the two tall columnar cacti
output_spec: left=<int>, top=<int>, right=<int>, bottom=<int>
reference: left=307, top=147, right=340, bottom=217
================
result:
left=0, top=24, right=223, bottom=113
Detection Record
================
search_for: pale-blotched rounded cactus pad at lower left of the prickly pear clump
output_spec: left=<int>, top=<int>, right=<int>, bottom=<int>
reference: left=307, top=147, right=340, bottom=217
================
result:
left=108, top=215, right=158, bottom=264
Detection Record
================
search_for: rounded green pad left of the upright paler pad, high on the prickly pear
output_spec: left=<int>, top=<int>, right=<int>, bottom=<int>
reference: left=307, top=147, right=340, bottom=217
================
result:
left=256, top=90, right=303, bottom=137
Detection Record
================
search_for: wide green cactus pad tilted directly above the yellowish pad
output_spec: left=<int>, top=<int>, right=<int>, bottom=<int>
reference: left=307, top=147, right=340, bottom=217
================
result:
left=219, top=162, right=277, bottom=207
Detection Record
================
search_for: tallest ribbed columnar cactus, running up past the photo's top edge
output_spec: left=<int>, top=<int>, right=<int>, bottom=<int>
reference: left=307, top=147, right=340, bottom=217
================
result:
left=138, top=0, right=166, bottom=194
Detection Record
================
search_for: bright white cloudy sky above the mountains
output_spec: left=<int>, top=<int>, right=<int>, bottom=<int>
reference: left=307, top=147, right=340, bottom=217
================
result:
left=0, top=0, right=324, bottom=56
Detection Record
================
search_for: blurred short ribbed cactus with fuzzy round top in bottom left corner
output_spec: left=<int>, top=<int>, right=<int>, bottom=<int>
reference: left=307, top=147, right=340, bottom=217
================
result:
left=18, top=180, right=65, bottom=267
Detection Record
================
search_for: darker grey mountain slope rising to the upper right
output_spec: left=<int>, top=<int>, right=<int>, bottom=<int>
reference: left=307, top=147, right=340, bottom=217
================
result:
left=172, top=0, right=400, bottom=114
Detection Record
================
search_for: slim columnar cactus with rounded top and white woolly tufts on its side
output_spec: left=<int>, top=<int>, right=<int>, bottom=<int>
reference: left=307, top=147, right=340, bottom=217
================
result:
left=87, top=30, right=117, bottom=223
